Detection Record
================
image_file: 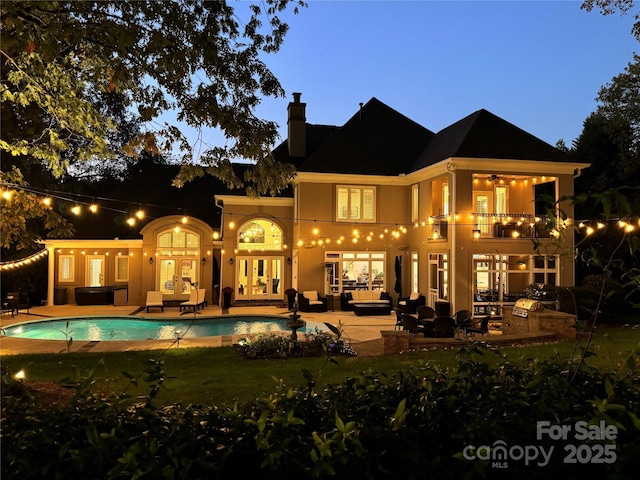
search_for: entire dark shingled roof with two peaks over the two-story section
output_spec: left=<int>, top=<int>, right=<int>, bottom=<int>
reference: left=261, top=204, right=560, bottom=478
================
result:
left=273, top=98, right=569, bottom=176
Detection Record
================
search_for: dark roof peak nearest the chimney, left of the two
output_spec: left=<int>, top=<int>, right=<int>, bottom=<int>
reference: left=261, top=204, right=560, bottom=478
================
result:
left=298, top=98, right=434, bottom=175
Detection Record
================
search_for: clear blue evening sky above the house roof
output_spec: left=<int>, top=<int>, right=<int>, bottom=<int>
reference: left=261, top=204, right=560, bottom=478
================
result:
left=186, top=0, right=640, bottom=156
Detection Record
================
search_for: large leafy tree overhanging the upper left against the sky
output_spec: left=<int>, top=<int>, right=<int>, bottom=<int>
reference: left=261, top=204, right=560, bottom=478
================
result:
left=0, top=0, right=304, bottom=195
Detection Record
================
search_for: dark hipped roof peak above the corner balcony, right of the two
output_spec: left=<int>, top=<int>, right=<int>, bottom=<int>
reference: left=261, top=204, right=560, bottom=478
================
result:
left=411, top=109, right=569, bottom=171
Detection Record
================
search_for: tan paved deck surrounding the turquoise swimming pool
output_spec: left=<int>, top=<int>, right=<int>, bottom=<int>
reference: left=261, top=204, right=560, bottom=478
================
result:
left=0, top=305, right=396, bottom=355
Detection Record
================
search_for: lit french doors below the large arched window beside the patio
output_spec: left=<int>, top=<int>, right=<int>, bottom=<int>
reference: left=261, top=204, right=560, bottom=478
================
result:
left=236, top=257, right=284, bottom=300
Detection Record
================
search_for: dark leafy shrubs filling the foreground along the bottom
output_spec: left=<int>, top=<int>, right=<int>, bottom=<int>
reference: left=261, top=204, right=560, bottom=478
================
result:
left=0, top=343, right=640, bottom=480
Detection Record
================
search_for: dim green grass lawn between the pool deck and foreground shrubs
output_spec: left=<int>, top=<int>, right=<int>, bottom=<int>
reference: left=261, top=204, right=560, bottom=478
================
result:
left=2, top=327, right=640, bottom=406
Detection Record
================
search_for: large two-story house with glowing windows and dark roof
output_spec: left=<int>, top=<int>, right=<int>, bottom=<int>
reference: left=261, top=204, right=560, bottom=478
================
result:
left=46, top=93, right=588, bottom=313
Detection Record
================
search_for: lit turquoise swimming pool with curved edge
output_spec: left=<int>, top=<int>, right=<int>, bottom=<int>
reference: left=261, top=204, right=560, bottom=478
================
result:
left=3, top=315, right=327, bottom=341
